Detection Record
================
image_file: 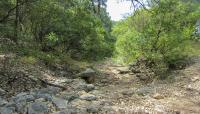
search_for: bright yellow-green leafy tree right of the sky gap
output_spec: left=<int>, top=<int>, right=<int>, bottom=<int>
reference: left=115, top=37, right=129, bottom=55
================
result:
left=113, top=0, right=200, bottom=66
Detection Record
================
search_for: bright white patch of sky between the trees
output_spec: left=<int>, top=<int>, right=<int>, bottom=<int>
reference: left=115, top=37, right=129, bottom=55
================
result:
left=107, top=0, right=133, bottom=21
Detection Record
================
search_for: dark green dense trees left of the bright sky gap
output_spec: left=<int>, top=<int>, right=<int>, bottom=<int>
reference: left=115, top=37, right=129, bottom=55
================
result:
left=0, top=0, right=114, bottom=60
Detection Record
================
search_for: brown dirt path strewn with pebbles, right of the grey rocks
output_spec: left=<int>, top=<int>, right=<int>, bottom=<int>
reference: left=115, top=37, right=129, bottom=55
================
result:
left=93, top=58, right=200, bottom=114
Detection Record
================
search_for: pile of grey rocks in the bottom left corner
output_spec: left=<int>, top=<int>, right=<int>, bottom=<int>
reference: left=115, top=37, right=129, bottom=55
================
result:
left=0, top=79, right=108, bottom=114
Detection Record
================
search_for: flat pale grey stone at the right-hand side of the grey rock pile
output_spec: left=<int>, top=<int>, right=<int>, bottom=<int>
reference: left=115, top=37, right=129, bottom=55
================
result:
left=52, top=97, right=68, bottom=109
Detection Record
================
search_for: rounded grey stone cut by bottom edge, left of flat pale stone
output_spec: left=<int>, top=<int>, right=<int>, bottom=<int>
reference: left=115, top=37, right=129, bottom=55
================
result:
left=28, top=102, right=48, bottom=114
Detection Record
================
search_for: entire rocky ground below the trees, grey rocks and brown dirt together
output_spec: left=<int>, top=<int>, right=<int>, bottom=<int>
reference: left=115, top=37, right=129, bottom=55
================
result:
left=0, top=54, right=200, bottom=114
